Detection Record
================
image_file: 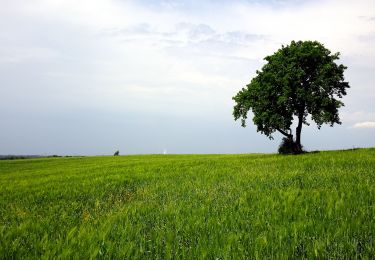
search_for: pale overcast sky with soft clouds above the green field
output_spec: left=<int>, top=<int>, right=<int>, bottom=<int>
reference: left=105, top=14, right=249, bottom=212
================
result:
left=0, top=0, right=375, bottom=155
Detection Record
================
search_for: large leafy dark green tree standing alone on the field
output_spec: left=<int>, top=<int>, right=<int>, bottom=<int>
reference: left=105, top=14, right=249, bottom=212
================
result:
left=233, top=41, right=349, bottom=154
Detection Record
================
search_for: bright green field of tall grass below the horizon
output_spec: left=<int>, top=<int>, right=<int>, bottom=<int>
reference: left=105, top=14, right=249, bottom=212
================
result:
left=0, top=149, right=375, bottom=259
